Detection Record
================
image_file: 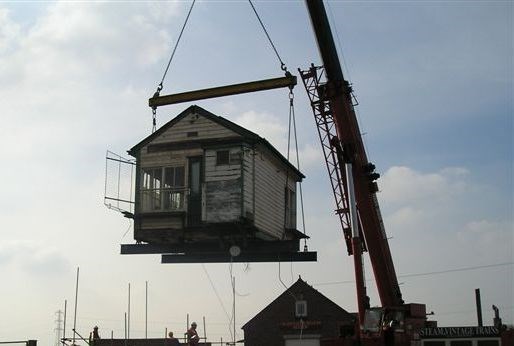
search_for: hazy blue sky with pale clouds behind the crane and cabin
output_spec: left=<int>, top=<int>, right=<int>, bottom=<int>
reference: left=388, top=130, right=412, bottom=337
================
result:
left=0, top=0, right=514, bottom=346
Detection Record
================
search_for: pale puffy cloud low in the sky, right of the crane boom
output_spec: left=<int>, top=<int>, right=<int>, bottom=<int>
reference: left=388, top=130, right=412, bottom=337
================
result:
left=379, top=166, right=514, bottom=265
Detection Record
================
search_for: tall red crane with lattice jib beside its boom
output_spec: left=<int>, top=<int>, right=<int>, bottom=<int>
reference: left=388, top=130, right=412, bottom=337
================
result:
left=299, top=0, right=426, bottom=345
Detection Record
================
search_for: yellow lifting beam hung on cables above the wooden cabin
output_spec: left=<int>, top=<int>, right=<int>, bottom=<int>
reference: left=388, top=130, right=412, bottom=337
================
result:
left=148, top=73, right=296, bottom=109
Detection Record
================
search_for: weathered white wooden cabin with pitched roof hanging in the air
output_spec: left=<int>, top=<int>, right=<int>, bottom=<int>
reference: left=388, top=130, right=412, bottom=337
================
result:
left=122, top=106, right=314, bottom=259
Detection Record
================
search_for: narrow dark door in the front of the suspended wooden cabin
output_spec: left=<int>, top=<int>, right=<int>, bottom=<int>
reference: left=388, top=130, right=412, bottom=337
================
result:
left=187, top=156, right=202, bottom=227
